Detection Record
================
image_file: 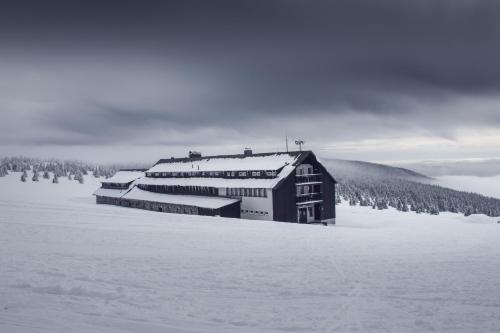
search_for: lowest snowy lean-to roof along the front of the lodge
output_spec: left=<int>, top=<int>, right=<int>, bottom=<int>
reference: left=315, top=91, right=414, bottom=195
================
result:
left=123, top=187, right=239, bottom=209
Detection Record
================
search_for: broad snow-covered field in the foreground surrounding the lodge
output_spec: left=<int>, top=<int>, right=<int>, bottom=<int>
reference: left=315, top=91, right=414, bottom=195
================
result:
left=0, top=174, right=500, bottom=332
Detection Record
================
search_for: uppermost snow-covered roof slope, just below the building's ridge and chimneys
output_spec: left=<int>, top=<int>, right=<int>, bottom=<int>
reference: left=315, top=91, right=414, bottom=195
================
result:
left=147, top=153, right=299, bottom=172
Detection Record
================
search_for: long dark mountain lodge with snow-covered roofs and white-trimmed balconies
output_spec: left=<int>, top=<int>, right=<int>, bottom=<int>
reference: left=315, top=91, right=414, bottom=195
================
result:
left=94, top=149, right=336, bottom=223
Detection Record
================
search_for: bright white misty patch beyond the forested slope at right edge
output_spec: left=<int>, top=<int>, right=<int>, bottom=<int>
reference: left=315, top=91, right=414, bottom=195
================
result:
left=435, top=175, right=500, bottom=199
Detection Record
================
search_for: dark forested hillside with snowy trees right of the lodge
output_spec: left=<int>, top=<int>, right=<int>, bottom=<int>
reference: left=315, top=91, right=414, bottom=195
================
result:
left=322, top=159, right=500, bottom=216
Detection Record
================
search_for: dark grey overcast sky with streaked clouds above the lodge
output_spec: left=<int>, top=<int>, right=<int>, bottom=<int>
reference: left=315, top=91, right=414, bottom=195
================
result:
left=0, top=0, right=500, bottom=162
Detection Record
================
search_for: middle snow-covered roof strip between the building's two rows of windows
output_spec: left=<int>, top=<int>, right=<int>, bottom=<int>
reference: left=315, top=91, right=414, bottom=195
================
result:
left=136, top=165, right=294, bottom=188
